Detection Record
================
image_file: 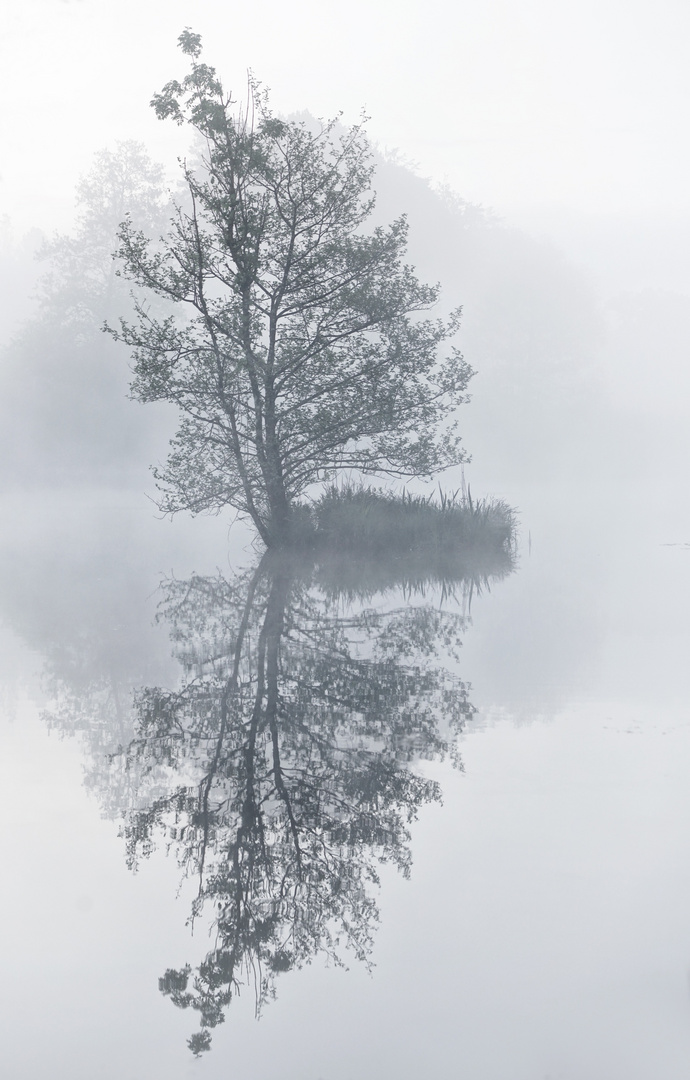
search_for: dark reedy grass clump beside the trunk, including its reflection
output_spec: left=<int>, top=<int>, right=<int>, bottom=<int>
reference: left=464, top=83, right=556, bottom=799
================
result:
left=285, top=485, right=516, bottom=596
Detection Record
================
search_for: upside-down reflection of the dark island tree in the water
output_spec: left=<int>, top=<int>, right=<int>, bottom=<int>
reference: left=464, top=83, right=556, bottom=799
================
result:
left=112, top=548, right=507, bottom=1053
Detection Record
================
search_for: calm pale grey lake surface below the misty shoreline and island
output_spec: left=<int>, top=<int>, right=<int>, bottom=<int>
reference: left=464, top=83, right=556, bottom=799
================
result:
left=0, top=481, right=690, bottom=1080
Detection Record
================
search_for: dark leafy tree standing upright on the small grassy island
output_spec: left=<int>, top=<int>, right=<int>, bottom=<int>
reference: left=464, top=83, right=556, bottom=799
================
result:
left=111, top=30, right=472, bottom=544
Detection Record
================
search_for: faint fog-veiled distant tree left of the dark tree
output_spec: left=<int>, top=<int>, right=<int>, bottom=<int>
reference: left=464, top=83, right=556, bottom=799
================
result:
left=0, top=141, right=168, bottom=485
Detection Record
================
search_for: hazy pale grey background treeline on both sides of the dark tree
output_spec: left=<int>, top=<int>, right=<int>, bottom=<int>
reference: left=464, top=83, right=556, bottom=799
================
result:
left=0, top=135, right=690, bottom=498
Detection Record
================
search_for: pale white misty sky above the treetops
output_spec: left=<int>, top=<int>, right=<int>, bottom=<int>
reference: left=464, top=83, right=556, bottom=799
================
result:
left=0, top=0, right=690, bottom=230
